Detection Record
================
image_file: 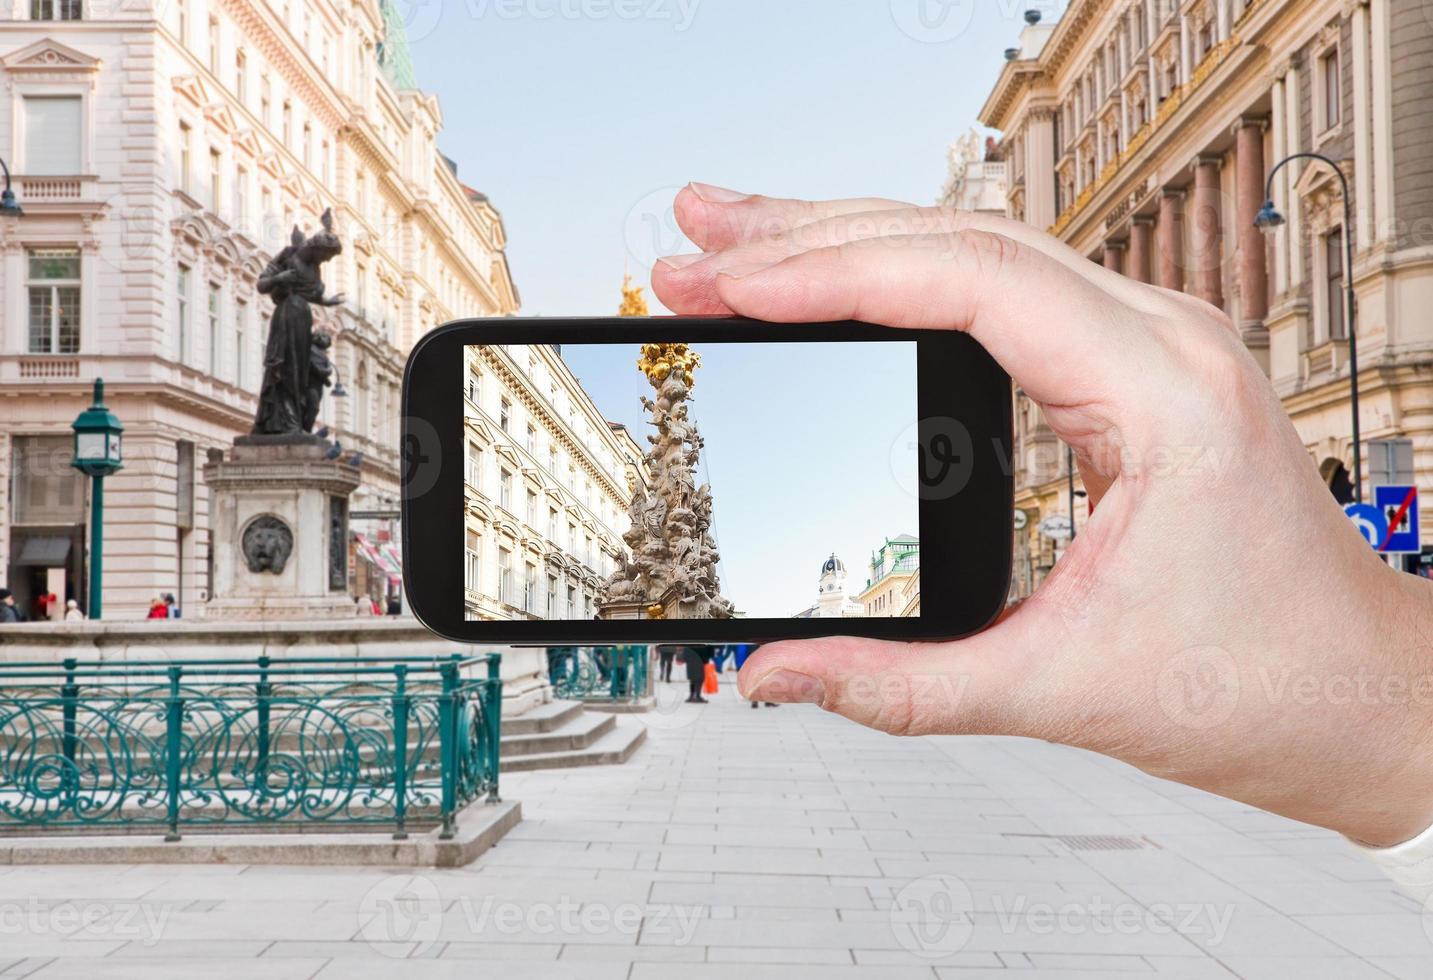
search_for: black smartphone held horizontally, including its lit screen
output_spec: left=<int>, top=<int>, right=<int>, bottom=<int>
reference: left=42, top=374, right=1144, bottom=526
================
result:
left=403, top=317, right=1015, bottom=645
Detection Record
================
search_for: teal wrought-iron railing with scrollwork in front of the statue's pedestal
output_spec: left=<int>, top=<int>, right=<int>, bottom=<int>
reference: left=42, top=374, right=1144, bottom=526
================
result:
left=0, top=653, right=503, bottom=841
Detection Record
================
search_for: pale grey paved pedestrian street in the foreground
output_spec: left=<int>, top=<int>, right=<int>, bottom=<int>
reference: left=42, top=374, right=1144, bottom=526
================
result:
left=0, top=675, right=1433, bottom=980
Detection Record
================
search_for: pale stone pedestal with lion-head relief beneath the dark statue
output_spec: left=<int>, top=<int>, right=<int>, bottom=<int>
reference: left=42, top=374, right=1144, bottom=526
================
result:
left=203, top=436, right=358, bottom=620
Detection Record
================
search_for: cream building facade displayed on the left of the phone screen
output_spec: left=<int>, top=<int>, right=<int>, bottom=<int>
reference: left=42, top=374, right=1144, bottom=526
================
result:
left=463, top=344, right=646, bottom=620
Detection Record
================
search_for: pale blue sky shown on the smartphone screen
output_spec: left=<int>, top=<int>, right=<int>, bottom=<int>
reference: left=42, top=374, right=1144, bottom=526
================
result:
left=562, top=344, right=920, bottom=618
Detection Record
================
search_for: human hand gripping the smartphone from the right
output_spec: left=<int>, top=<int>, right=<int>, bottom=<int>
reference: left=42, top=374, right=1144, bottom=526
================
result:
left=652, top=185, right=1433, bottom=845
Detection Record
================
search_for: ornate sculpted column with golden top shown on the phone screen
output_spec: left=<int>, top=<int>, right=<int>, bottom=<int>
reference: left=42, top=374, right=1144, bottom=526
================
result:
left=598, top=343, right=734, bottom=619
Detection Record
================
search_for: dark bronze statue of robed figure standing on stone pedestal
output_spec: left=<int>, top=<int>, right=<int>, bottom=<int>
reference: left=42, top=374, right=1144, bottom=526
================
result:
left=254, top=211, right=344, bottom=436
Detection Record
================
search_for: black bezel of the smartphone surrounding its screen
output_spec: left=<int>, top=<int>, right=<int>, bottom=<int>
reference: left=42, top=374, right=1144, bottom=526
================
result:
left=401, top=317, right=1015, bottom=646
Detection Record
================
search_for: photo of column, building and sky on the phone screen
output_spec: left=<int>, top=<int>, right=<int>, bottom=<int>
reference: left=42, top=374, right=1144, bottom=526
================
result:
left=463, top=341, right=920, bottom=622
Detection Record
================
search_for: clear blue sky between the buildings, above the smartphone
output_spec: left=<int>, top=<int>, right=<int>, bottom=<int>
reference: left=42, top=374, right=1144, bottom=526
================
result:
left=396, top=0, right=1062, bottom=315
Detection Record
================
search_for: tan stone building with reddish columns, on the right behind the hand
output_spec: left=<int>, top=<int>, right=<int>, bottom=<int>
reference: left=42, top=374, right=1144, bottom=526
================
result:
left=980, top=0, right=1433, bottom=595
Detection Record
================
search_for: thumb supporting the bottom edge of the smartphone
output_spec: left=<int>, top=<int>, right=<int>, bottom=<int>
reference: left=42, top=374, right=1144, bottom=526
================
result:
left=737, top=610, right=1054, bottom=735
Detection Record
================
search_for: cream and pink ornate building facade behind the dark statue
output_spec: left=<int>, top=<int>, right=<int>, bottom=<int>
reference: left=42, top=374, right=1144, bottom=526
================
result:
left=0, top=0, right=519, bottom=618
